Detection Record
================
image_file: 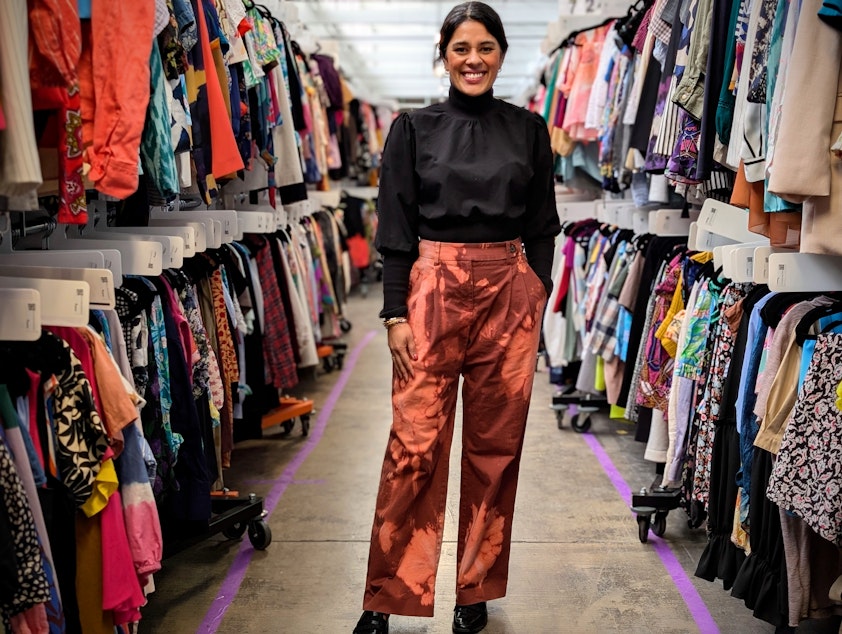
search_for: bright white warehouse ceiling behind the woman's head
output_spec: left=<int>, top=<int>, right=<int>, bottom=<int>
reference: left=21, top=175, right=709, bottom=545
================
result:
left=284, top=0, right=559, bottom=107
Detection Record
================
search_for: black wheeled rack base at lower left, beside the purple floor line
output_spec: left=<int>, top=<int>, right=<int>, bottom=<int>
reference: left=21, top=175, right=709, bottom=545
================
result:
left=164, top=490, right=272, bottom=558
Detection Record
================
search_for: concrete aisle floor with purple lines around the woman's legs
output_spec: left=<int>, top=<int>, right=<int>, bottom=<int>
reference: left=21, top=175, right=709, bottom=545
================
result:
left=140, top=287, right=792, bottom=634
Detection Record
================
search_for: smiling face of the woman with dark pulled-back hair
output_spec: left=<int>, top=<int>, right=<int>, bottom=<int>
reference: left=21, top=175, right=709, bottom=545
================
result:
left=444, top=20, right=503, bottom=97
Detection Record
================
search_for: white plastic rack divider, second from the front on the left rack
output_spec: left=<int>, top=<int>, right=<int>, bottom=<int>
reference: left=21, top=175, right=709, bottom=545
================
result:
left=0, top=277, right=91, bottom=328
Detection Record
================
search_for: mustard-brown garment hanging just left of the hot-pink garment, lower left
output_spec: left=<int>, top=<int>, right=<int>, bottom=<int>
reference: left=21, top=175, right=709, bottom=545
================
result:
left=76, top=513, right=114, bottom=634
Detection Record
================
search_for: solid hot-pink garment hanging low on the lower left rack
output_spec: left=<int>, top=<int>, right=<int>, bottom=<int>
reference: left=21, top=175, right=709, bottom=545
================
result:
left=100, top=491, right=146, bottom=625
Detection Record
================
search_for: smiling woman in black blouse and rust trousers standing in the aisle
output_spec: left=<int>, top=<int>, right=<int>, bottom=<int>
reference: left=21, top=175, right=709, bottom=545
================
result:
left=354, top=2, right=560, bottom=634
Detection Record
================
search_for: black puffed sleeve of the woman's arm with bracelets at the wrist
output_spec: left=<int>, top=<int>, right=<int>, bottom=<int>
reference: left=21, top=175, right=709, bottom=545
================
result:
left=374, top=114, right=418, bottom=318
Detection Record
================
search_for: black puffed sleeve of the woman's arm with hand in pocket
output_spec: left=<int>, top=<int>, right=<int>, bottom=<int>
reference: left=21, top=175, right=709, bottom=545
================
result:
left=521, top=114, right=561, bottom=295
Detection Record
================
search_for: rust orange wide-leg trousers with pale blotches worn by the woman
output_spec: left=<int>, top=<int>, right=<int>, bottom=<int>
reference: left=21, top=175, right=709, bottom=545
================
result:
left=363, top=240, right=546, bottom=616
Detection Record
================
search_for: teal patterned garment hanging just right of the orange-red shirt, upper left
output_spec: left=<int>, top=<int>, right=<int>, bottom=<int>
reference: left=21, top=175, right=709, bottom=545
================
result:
left=140, top=40, right=179, bottom=200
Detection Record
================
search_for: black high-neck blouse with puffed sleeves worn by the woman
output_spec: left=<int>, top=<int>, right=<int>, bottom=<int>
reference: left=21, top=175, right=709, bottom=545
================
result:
left=375, top=88, right=561, bottom=317
